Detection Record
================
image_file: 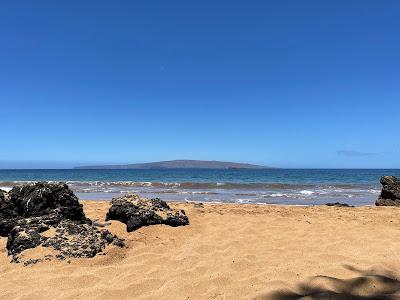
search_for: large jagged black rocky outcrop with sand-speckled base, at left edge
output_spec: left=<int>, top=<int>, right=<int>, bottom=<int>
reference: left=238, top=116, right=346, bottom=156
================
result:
left=0, top=182, right=123, bottom=262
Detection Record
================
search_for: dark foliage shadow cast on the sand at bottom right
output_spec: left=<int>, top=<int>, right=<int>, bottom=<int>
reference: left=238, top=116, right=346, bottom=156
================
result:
left=261, top=266, right=400, bottom=300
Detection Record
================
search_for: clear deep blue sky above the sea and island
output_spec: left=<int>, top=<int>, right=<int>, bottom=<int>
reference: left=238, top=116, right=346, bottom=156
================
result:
left=0, top=0, right=400, bottom=168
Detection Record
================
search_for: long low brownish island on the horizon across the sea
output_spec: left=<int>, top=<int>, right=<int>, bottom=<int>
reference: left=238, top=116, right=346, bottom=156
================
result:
left=74, top=160, right=270, bottom=169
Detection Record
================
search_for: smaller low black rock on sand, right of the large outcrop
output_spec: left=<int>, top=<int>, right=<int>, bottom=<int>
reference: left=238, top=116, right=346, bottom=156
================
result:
left=106, top=195, right=189, bottom=232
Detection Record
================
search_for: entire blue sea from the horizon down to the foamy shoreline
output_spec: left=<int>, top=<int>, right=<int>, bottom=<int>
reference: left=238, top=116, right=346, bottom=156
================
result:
left=0, top=169, right=400, bottom=205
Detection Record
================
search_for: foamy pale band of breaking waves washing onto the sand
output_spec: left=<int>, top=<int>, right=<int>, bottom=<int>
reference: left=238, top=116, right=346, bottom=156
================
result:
left=0, top=181, right=380, bottom=205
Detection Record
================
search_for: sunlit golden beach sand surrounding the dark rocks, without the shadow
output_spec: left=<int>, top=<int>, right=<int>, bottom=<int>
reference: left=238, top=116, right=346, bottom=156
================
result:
left=0, top=201, right=400, bottom=299
